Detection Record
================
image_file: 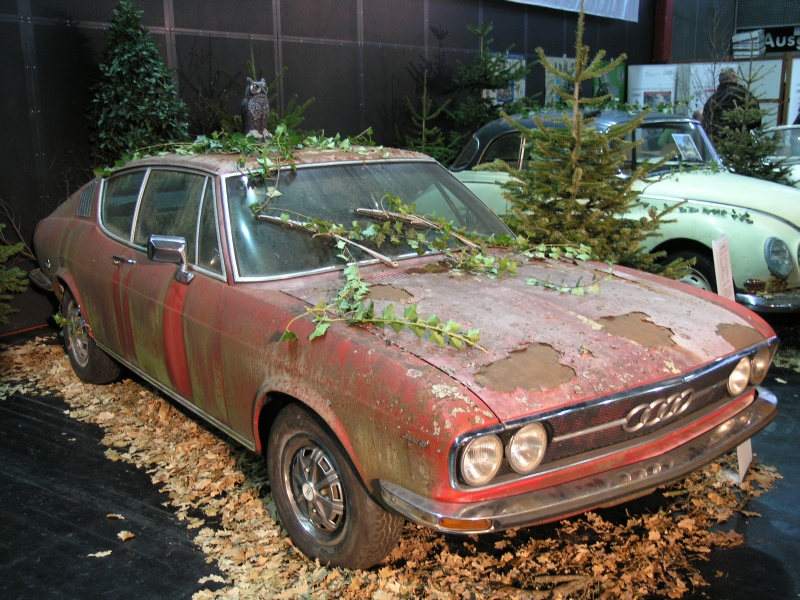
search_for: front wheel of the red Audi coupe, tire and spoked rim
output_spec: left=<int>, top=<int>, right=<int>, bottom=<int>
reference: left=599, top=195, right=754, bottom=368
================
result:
left=267, top=405, right=404, bottom=569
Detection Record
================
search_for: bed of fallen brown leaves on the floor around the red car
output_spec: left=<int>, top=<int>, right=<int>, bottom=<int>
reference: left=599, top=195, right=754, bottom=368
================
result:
left=0, top=339, right=780, bottom=600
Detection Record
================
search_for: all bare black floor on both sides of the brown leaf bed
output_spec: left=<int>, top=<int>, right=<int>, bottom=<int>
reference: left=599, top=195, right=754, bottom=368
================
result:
left=0, top=284, right=800, bottom=600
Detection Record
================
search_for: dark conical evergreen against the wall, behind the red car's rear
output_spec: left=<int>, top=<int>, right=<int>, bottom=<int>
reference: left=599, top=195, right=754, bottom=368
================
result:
left=89, top=0, right=189, bottom=166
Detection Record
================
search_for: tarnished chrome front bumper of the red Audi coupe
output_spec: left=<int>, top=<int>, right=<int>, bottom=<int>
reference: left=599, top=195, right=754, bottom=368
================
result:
left=380, top=388, right=778, bottom=533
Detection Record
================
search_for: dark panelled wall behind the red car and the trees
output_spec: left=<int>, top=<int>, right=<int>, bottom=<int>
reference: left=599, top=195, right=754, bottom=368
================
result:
left=0, top=0, right=656, bottom=245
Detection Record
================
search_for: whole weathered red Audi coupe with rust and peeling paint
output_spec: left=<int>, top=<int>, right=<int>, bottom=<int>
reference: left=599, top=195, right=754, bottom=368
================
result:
left=31, top=148, right=777, bottom=568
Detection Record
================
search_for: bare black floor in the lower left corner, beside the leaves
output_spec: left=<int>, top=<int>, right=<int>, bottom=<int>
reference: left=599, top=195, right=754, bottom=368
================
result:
left=0, top=396, right=219, bottom=600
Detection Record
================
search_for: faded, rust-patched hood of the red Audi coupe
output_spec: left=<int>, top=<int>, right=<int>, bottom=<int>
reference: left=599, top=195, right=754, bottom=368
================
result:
left=286, top=258, right=772, bottom=421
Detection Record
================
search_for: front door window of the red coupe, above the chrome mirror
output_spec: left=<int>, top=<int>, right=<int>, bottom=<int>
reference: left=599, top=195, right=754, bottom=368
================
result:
left=133, top=170, right=208, bottom=259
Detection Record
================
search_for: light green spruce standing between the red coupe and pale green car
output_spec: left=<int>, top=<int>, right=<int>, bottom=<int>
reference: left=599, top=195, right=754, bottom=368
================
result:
left=505, top=6, right=676, bottom=273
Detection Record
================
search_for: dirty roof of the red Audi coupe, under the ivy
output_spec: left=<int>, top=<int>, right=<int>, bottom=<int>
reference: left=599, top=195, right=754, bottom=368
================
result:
left=110, top=146, right=435, bottom=175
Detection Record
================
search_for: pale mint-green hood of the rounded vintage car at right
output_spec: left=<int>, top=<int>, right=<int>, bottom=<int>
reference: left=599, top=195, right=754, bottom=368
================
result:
left=641, top=171, right=800, bottom=226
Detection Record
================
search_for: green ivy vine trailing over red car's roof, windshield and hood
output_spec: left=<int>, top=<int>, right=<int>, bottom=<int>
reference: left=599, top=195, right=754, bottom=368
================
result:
left=96, top=123, right=598, bottom=352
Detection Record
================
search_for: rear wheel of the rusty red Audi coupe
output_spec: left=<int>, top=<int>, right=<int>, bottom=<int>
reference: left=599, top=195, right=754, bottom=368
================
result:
left=61, top=290, right=120, bottom=384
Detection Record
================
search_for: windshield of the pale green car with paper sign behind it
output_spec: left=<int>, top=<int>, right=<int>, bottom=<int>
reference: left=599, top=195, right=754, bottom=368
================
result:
left=628, top=122, right=719, bottom=174
